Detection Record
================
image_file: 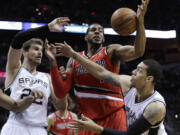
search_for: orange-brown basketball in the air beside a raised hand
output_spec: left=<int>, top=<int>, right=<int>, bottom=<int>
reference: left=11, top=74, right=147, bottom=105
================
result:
left=111, top=8, right=137, bottom=36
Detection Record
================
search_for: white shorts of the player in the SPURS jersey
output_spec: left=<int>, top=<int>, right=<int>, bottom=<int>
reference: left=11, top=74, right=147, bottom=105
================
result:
left=1, top=120, right=47, bottom=135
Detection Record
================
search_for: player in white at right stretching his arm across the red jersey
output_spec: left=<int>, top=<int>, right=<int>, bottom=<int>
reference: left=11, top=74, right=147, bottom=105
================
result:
left=55, top=43, right=167, bottom=135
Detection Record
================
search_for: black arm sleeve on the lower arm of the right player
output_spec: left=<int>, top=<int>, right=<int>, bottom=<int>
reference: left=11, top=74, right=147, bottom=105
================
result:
left=101, top=115, right=152, bottom=135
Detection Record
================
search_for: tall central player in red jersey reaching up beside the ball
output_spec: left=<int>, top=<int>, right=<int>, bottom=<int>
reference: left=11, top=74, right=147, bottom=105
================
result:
left=46, top=0, right=149, bottom=134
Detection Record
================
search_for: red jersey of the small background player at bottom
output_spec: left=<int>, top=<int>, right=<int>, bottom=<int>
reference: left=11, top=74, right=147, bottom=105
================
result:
left=51, top=111, right=74, bottom=135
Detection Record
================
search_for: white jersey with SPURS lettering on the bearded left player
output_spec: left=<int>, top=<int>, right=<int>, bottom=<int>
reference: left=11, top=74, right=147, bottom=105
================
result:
left=8, top=67, right=51, bottom=127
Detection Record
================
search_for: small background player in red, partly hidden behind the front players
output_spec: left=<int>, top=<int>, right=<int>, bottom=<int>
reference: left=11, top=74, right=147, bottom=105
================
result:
left=47, top=95, right=78, bottom=135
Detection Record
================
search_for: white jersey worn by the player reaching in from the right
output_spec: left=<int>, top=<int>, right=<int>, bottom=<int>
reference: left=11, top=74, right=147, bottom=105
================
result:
left=124, top=88, right=167, bottom=135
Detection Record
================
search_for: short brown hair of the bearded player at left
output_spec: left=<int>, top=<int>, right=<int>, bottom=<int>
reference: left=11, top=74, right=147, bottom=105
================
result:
left=23, top=38, right=44, bottom=51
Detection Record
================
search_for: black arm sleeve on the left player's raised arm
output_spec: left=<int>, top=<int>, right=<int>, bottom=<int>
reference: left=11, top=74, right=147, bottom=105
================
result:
left=11, top=25, right=50, bottom=49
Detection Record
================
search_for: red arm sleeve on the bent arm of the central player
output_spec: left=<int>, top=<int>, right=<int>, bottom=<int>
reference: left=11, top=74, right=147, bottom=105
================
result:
left=50, top=66, right=72, bottom=98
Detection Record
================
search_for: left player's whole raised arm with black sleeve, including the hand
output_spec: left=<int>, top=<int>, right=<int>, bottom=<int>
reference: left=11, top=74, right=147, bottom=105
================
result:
left=5, top=17, right=70, bottom=87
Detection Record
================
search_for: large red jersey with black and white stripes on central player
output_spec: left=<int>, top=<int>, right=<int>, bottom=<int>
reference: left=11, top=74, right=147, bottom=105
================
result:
left=72, top=47, right=124, bottom=120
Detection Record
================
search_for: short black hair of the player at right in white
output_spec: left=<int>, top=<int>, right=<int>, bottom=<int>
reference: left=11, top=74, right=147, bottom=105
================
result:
left=143, top=59, right=162, bottom=84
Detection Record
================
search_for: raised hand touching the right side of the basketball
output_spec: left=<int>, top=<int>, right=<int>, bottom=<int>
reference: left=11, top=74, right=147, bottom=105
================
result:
left=137, top=0, right=150, bottom=23
